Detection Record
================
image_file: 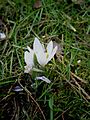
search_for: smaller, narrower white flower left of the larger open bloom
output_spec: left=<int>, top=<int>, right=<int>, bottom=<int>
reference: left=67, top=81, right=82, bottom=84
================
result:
left=24, top=46, right=34, bottom=73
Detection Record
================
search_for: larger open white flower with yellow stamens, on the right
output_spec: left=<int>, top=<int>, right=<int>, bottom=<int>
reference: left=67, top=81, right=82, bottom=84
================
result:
left=33, top=38, right=57, bottom=66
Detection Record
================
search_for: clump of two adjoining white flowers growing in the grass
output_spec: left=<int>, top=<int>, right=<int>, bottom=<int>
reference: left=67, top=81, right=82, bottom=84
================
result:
left=24, top=38, right=57, bottom=73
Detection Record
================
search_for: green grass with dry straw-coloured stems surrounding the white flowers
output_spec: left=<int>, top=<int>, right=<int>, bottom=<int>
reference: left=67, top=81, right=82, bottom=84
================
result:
left=0, top=0, right=90, bottom=120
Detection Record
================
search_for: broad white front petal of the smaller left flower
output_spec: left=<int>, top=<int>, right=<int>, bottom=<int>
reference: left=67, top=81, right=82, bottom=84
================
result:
left=24, top=50, right=34, bottom=67
